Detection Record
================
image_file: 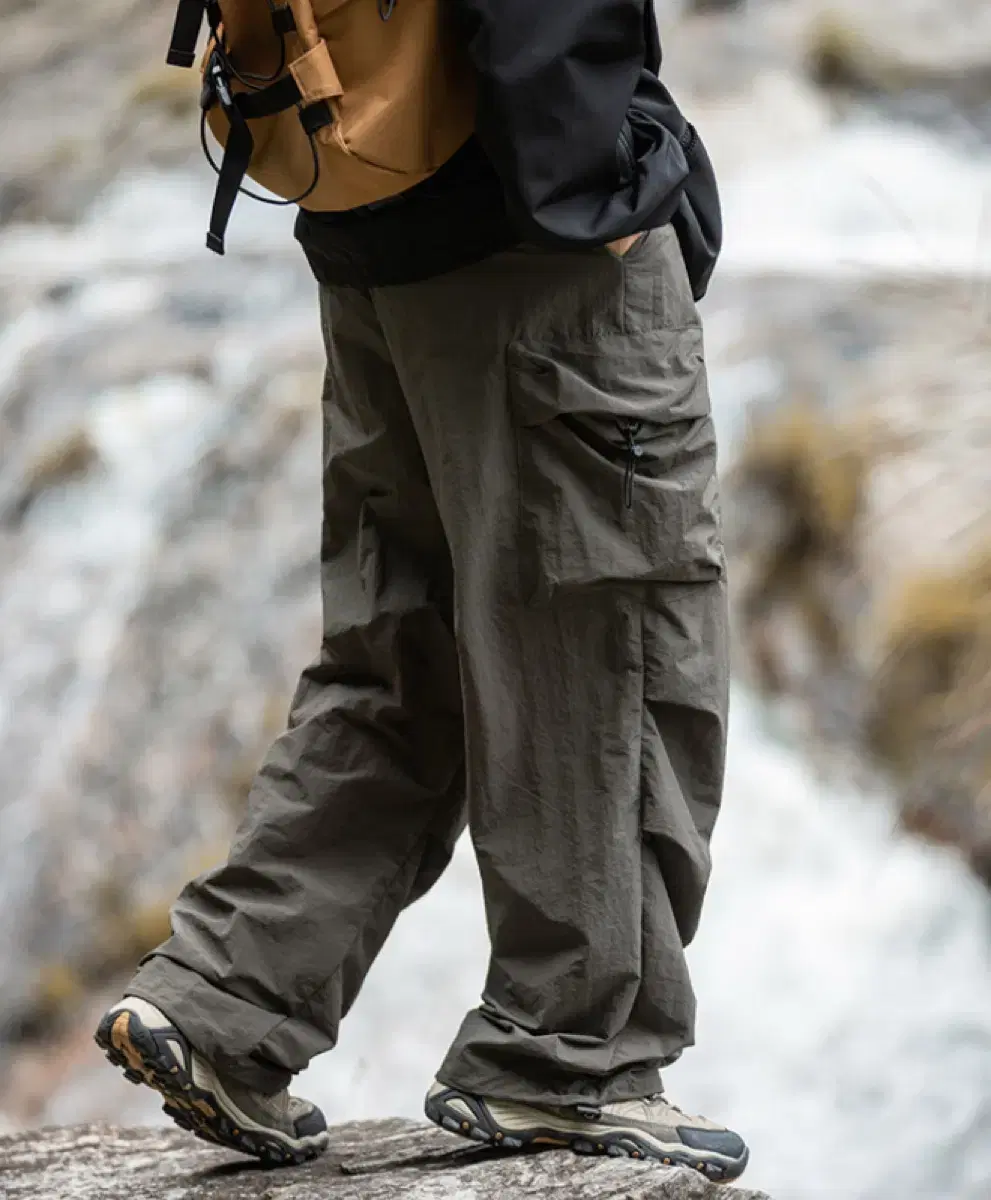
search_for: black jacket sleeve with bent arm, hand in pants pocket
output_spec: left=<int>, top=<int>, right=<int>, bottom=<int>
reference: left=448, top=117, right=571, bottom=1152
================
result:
left=451, top=0, right=693, bottom=246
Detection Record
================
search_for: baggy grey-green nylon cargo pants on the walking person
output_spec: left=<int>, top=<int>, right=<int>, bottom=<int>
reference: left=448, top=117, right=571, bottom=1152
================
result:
left=130, top=228, right=728, bottom=1104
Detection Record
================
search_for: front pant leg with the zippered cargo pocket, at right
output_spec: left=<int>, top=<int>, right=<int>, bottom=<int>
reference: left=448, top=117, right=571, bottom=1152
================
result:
left=373, top=229, right=728, bottom=1104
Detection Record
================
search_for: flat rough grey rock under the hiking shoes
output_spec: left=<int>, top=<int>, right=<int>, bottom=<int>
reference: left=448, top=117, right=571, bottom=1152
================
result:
left=0, top=1121, right=767, bottom=1200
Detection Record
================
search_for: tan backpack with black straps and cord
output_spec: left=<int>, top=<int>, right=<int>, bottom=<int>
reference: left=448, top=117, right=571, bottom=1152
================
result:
left=168, top=0, right=475, bottom=254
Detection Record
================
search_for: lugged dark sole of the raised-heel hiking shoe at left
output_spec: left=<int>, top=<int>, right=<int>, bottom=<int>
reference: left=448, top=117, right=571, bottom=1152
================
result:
left=95, top=1008, right=326, bottom=1168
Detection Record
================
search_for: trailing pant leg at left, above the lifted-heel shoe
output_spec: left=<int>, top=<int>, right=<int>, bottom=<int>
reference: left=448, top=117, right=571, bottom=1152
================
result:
left=130, top=289, right=466, bottom=1091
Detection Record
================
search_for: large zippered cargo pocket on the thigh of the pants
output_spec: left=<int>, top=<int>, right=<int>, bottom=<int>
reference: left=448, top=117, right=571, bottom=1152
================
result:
left=509, top=325, right=723, bottom=605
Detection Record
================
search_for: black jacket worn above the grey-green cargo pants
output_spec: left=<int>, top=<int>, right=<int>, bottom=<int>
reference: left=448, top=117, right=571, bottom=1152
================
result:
left=298, top=0, right=721, bottom=298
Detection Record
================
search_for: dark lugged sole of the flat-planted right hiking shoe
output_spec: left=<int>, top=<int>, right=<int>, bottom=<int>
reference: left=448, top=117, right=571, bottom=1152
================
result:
left=425, top=1092, right=750, bottom=1183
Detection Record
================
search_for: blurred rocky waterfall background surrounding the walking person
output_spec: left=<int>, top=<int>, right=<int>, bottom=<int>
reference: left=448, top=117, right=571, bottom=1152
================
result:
left=0, top=0, right=991, bottom=1200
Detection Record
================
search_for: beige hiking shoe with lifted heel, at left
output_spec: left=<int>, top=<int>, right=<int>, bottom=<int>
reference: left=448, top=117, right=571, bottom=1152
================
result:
left=96, top=996, right=329, bottom=1166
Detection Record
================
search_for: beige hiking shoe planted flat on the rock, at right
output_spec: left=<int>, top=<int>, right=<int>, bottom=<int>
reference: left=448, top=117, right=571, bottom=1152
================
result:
left=425, top=1082, right=750, bottom=1183
